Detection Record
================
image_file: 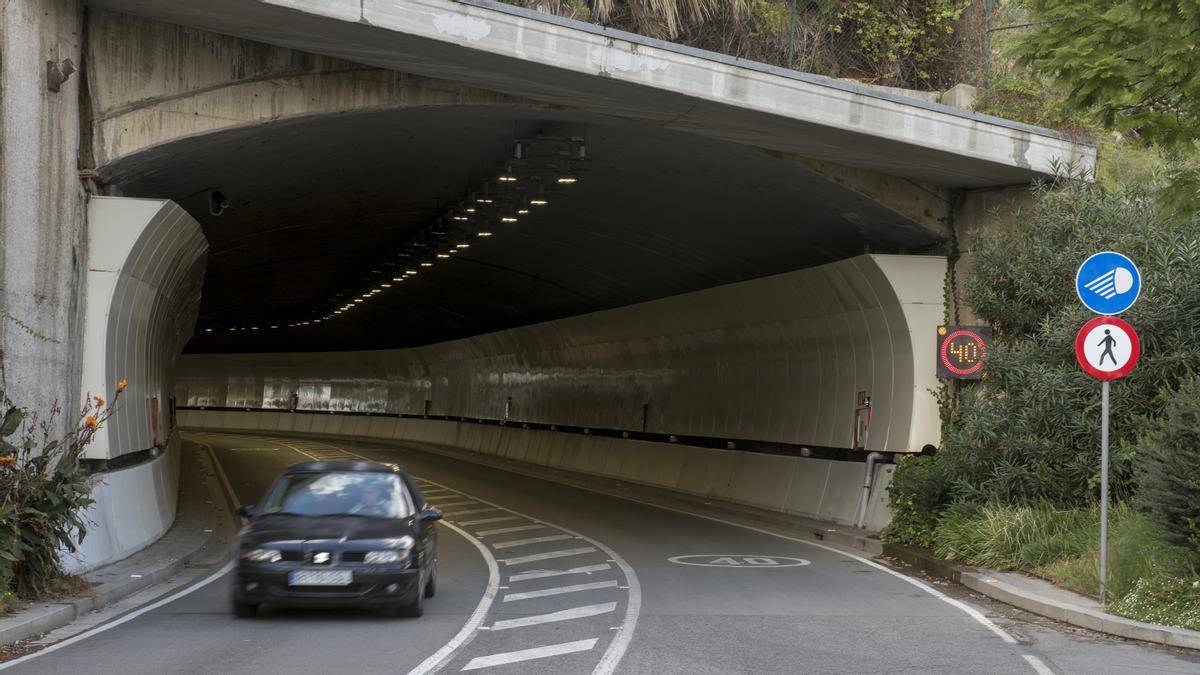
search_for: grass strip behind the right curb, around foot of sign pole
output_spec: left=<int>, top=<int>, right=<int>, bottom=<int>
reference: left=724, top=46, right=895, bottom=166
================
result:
left=934, top=504, right=1200, bottom=629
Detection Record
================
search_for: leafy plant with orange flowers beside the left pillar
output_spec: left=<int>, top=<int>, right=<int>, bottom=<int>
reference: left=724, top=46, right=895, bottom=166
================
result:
left=0, top=360, right=125, bottom=611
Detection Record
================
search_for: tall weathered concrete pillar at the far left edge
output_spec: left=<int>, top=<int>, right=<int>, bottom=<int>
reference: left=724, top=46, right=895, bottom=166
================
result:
left=0, top=0, right=86, bottom=429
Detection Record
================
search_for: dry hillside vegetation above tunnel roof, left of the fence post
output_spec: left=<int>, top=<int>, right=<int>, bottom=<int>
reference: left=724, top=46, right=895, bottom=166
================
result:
left=509, top=0, right=983, bottom=89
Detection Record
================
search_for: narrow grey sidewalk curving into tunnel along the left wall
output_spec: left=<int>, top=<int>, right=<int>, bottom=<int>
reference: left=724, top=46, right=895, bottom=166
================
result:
left=0, top=441, right=234, bottom=646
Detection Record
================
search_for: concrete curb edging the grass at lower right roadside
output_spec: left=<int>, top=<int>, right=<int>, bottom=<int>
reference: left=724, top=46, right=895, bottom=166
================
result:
left=883, top=543, right=1200, bottom=650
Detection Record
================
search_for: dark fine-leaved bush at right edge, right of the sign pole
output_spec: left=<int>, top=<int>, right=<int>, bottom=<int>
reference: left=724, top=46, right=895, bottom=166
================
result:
left=1138, top=380, right=1200, bottom=571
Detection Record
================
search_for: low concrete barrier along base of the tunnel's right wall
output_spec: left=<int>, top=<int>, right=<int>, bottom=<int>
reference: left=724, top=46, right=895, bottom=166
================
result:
left=179, top=410, right=894, bottom=530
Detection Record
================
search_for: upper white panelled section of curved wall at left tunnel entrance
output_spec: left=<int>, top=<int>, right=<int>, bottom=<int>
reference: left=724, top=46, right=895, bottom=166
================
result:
left=83, top=197, right=208, bottom=459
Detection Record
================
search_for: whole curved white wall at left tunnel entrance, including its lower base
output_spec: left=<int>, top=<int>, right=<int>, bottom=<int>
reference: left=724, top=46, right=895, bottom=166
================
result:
left=71, top=197, right=208, bottom=573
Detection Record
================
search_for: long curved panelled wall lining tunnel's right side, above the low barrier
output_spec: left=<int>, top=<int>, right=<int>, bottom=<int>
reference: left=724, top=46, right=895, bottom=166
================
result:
left=178, top=256, right=946, bottom=453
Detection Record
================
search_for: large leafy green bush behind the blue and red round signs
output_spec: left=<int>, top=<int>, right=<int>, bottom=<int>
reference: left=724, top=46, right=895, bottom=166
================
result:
left=884, top=180, right=1200, bottom=543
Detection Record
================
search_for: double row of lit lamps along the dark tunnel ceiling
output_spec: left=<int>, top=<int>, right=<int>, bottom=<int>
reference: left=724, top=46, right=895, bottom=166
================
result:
left=197, top=136, right=588, bottom=333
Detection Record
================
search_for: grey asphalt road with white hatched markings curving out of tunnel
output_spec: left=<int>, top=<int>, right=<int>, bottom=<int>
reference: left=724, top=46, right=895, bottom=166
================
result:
left=10, top=434, right=1200, bottom=675
